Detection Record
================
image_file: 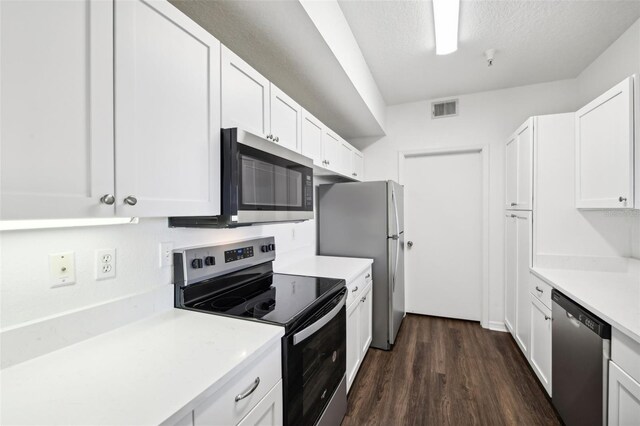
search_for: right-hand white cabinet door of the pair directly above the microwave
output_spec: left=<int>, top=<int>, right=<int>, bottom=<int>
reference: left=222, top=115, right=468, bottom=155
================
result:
left=271, top=84, right=302, bottom=152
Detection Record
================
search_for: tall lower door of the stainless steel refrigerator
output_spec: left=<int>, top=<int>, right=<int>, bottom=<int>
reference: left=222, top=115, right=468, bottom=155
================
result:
left=388, top=232, right=405, bottom=344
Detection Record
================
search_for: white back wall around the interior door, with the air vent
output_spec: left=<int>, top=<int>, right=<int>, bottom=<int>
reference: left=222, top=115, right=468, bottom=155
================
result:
left=354, top=80, right=577, bottom=323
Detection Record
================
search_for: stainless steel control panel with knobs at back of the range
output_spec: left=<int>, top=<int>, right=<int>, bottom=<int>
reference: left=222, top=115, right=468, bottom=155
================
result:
left=173, top=237, right=276, bottom=286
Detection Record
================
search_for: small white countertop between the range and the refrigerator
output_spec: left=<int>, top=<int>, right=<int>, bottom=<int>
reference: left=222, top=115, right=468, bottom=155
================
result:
left=276, top=256, right=373, bottom=282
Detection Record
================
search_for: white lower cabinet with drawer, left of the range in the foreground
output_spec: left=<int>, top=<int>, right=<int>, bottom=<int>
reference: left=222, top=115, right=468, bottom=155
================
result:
left=193, top=342, right=282, bottom=426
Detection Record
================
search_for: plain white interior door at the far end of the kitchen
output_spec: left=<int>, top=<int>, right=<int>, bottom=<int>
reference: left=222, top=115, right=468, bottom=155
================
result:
left=403, top=152, right=483, bottom=321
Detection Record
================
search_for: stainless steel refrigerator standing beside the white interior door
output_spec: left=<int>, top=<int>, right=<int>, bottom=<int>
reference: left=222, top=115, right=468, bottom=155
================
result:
left=318, top=181, right=405, bottom=350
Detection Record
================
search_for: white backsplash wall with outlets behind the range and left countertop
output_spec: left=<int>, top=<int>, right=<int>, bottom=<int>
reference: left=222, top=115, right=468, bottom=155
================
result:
left=0, top=218, right=315, bottom=330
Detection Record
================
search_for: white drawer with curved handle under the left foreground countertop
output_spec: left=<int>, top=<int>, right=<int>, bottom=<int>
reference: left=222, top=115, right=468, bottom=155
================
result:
left=194, top=342, right=282, bottom=425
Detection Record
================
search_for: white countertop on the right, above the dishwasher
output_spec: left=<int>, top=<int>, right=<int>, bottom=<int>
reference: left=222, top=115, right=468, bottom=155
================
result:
left=531, top=261, right=640, bottom=343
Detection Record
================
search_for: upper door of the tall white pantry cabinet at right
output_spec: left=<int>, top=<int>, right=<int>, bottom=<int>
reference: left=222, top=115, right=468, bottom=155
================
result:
left=505, top=118, right=533, bottom=210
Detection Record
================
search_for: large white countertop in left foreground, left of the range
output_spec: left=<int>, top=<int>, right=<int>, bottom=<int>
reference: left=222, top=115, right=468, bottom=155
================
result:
left=0, top=309, right=284, bottom=425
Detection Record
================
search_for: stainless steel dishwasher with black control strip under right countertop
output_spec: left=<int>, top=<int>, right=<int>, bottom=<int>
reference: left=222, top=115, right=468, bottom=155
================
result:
left=551, top=290, right=611, bottom=426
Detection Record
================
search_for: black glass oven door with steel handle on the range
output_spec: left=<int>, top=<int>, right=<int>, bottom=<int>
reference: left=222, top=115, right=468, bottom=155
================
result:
left=283, top=289, right=346, bottom=425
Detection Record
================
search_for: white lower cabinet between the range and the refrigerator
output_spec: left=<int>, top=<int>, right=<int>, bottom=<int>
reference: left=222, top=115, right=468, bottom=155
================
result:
left=347, top=268, right=373, bottom=391
